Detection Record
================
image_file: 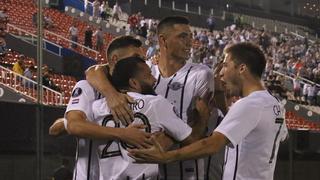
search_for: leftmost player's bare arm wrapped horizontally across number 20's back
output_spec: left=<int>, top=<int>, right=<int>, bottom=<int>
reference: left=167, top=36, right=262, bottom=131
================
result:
left=66, top=110, right=150, bottom=147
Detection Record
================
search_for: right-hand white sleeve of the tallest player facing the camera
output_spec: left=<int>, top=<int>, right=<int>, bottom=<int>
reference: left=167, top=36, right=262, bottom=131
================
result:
left=195, top=66, right=214, bottom=97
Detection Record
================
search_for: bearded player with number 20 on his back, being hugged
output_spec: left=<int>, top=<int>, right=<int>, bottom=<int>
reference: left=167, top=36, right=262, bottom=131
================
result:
left=93, top=57, right=209, bottom=179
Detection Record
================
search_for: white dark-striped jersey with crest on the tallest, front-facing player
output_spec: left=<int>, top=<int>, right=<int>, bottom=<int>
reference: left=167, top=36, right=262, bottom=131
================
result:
left=149, top=63, right=214, bottom=180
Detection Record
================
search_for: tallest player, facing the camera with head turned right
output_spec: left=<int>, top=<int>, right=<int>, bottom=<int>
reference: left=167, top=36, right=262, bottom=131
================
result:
left=85, top=16, right=222, bottom=180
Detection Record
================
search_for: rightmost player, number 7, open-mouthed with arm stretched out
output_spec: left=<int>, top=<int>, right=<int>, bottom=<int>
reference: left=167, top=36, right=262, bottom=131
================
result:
left=129, top=43, right=287, bottom=180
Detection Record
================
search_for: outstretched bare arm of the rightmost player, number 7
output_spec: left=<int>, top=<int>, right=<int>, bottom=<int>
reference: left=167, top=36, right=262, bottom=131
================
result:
left=129, top=132, right=229, bottom=163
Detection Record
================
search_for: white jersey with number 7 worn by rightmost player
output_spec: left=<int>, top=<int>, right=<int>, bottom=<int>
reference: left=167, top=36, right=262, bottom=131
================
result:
left=215, top=90, right=288, bottom=180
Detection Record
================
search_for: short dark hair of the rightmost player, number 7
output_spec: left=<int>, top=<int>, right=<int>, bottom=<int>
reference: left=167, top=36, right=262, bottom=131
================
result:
left=224, top=42, right=266, bottom=78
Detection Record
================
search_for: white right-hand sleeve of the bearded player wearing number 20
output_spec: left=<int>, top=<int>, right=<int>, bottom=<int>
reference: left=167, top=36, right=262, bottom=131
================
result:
left=152, top=96, right=192, bottom=142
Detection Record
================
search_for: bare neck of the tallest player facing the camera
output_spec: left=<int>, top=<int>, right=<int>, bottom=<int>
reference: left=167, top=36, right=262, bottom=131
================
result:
left=158, top=56, right=186, bottom=78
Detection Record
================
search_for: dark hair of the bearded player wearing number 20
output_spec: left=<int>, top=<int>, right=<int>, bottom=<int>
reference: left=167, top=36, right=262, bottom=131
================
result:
left=111, top=57, right=145, bottom=90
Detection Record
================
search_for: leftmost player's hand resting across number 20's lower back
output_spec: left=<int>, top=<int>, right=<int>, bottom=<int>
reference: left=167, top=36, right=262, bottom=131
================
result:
left=121, top=124, right=152, bottom=148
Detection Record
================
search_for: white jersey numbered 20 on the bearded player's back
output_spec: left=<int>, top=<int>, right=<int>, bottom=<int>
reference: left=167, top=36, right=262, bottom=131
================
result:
left=92, top=92, right=192, bottom=180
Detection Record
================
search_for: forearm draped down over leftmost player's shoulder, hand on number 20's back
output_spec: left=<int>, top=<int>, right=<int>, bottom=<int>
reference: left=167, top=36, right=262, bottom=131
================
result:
left=86, top=64, right=133, bottom=124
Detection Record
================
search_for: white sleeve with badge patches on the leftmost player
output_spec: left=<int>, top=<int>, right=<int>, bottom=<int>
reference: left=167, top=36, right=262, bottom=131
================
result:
left=65, top=80, right=95, bottom=120
